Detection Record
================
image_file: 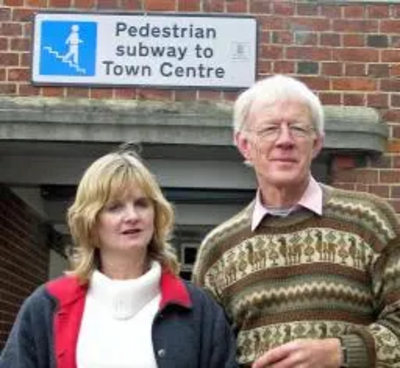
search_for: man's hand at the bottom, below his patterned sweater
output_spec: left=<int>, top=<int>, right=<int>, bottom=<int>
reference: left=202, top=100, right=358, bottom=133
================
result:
left=252, top=338, right=342, bottom=368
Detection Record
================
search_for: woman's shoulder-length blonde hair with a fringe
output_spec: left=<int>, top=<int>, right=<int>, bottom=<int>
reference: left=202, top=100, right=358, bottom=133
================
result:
left=67, top=150, right=179, bottom=283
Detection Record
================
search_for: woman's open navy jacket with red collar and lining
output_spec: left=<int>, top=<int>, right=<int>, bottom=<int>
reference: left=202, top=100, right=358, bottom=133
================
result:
left=0, top=272, right=238, bottom=368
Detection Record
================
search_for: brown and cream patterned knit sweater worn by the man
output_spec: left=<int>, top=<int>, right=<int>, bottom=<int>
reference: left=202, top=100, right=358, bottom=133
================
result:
left=194, top=185, right=400, bottom=368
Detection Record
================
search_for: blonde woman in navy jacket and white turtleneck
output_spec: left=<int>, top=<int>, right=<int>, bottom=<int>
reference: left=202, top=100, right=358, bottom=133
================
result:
left=0, top=151, right=236, bottom=368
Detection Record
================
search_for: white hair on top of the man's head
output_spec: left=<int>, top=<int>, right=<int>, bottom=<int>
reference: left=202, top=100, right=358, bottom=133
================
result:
left=233, top=74, right=324, bottom=136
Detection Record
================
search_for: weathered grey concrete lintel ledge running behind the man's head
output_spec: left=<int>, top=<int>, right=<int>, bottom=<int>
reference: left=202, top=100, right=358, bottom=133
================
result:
left=0, top=97, right=388, bottom=153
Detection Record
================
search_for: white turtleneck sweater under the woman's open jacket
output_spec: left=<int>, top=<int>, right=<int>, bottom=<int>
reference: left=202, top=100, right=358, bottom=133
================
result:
left=77, top=262, right=161, bottom=368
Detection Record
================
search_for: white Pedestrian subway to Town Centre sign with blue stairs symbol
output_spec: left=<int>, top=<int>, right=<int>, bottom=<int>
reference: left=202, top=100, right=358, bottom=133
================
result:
left=32, top=13, right=257, bottom=88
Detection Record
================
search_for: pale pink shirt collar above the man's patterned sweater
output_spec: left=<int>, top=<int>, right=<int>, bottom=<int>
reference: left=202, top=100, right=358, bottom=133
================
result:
left=251, top=176, right=322, bottom=231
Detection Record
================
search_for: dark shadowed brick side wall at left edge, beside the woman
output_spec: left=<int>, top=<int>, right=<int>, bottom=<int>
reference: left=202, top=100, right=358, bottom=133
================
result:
left=0, top=186, right=49, bottom=350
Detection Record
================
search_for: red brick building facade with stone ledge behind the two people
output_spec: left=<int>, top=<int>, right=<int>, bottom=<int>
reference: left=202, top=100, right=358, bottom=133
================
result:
left=0, top=0, right=400, bottom=349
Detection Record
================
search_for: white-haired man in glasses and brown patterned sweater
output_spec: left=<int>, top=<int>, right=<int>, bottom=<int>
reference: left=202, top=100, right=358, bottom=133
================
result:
left=194, top=75, right=400, bottom=368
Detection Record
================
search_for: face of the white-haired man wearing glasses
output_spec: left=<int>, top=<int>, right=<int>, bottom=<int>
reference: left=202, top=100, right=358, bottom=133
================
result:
left=235, top=100, right=323, bottom=188
